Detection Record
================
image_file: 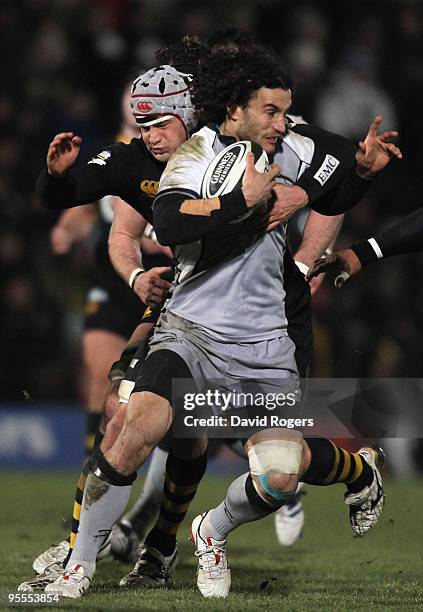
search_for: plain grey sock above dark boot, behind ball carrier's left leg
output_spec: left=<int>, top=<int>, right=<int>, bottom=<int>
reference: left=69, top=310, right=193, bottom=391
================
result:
left=124, top=447, right=168, bottom=541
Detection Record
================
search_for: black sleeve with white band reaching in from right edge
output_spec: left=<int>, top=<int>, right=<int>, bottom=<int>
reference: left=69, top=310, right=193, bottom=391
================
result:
left=351, top=208, right=423, bottom=266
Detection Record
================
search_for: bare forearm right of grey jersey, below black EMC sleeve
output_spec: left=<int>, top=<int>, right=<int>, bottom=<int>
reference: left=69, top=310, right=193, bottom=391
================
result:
left=294, top=210, right=344, bottom=267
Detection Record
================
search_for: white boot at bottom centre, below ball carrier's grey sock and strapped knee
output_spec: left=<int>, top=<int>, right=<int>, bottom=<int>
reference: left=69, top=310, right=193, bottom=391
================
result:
left=191, top=512, right=231, bottom=597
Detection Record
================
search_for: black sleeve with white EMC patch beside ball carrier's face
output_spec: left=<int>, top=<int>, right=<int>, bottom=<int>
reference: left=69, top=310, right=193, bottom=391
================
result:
left=294, top=124, right=371, bottom=215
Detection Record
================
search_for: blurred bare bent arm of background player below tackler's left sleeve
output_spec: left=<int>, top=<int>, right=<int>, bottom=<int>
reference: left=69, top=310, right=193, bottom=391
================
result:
left=50, top=204, right=98, bottom=255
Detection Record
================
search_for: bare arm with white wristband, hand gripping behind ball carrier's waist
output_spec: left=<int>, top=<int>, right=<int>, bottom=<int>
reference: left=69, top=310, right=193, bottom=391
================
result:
left=109, top=197, right=172, bottom=306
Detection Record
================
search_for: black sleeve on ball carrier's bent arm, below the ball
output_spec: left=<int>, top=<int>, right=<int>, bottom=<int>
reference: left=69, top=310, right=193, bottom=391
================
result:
left=153, top=189, right=248, bottom=246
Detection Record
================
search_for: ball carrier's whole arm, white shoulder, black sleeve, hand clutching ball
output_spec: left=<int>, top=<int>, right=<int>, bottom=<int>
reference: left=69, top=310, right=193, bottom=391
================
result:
left=153, top=137, right=280, bottom=246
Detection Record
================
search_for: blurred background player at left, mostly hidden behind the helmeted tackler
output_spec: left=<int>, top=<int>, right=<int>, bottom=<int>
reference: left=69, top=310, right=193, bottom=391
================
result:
left=50, top=86, right=147, bottom=455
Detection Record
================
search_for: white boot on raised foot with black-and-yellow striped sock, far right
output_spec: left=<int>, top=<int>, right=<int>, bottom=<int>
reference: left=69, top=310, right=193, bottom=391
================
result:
left=345, top=447, right=385, bottom=535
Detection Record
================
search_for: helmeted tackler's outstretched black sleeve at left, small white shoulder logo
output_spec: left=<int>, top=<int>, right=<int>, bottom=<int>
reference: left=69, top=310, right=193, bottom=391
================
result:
left=36, top=143, right=126, bottom=210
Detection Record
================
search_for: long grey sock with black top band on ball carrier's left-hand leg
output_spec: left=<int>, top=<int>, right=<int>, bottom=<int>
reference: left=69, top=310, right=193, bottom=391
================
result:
left=66, top=449, right=136, bottom=576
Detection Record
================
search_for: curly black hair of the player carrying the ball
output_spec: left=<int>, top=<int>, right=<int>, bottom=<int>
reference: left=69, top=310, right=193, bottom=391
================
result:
left=191, top=44, right=293, bottom=125
